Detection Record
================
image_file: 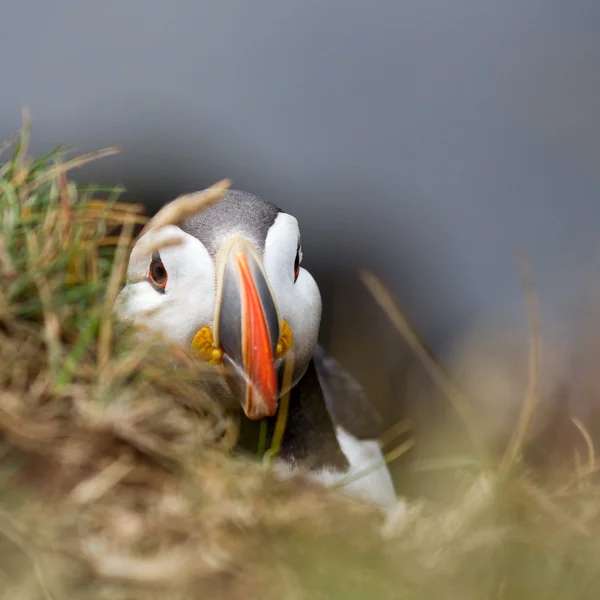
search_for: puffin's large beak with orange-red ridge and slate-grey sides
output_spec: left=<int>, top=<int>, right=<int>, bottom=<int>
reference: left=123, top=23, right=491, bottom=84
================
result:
left=215, top=238, right=280, bottom=419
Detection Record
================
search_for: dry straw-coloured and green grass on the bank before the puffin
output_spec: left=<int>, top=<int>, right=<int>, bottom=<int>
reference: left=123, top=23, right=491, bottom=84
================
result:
left=0, top=118, right=600, bottom=600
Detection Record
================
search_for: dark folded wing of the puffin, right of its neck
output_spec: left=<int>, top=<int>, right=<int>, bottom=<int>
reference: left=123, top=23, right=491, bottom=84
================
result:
left=313, top=345, right=383, bottom=440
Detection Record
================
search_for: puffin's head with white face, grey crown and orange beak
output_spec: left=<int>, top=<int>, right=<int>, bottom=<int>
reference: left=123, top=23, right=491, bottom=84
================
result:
left=115, top=190, right=321, bottom=419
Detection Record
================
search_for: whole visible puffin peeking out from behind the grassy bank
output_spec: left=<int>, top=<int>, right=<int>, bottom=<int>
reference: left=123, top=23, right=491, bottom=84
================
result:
left=115, top=189, right=397, bottom=509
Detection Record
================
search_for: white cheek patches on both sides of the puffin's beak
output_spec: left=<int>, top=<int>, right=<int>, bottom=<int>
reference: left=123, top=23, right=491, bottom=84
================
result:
left=116, top=213, right=321, bottom=381
